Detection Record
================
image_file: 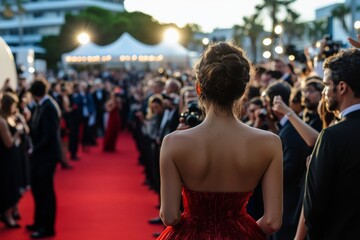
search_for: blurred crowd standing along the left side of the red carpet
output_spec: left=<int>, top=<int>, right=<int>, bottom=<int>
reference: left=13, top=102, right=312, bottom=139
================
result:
left=0, top=70, right=128, bottom=238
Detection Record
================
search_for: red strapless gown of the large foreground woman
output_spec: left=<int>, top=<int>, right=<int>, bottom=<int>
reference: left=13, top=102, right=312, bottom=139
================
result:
left=158, top=187, right=266, bottom=240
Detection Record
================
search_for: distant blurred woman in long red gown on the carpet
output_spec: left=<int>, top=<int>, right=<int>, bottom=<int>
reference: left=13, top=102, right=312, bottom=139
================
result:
left=103, top=93, right=121, bottom=152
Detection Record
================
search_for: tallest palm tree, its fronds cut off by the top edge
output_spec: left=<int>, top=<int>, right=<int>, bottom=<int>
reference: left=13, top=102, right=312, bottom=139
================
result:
left=255, top=0, right=296, bottom=39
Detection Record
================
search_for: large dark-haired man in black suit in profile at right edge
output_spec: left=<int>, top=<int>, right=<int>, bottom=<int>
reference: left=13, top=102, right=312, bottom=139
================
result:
left=304, top=49, right=360, bottom=240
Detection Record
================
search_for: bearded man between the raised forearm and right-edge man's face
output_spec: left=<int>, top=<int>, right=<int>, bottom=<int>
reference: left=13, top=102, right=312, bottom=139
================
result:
left=302, top=76, right=324, bottom=132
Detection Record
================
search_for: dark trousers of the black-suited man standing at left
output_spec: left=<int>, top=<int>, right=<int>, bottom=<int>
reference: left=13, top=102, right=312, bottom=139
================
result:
left=31, top=163, right=56, bottom=231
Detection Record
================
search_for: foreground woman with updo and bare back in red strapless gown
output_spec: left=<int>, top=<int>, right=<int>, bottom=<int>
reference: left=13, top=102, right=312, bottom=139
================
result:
left=158, top=42, right=283, bottom=240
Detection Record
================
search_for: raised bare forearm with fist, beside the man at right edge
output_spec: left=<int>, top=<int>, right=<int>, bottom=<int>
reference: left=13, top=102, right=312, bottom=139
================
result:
left=273, top=96, right=319, bottom=147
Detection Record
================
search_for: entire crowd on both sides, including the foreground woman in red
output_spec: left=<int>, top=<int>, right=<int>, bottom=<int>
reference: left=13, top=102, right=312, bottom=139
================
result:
left=0, top=34, right=360, bottom=240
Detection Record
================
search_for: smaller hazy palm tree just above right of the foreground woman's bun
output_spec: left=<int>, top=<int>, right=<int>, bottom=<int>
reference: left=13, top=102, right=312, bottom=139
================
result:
left=234, top=14, right=264, bottom=62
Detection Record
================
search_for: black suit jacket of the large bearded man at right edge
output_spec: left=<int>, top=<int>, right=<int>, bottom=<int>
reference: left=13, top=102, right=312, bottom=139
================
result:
left=304, top=110, right=360, bottom=240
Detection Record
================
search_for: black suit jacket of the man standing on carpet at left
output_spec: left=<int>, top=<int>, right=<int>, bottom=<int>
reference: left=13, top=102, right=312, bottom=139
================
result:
left=30, top=98, right=61, bottom=165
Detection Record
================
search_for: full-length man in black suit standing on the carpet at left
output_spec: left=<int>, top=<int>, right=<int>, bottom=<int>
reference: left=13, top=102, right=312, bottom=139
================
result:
left=27, top=80, right=61, bottom=238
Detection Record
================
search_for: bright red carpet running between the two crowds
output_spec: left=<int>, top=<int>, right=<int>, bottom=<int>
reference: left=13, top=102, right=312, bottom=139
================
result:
left=0, top=133, right=163, bottom=240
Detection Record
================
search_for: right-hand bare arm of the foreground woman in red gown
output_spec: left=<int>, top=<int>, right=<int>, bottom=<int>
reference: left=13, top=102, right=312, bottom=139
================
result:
left=257, top=135, right=283, bottom=235
